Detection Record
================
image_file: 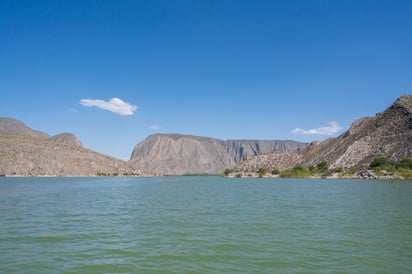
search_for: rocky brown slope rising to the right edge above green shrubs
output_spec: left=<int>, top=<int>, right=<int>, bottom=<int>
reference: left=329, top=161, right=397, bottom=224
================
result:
left=234, top=95, right=412, bottom=174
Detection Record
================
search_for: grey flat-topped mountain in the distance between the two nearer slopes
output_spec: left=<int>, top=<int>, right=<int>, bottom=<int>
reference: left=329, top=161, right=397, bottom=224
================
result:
left=129, top=134, right=307, bottom=175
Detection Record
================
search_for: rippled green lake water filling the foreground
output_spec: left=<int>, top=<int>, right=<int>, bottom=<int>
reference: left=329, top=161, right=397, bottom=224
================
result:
left=0, top=177, right=412, bottom=273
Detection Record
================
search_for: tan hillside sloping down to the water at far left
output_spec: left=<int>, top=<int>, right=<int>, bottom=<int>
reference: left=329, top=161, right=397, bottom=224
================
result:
left=0, top=118, right=143, bottom=176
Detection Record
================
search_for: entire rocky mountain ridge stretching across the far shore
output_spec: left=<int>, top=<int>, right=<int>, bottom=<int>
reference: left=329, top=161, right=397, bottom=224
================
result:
left=0, top=95, right=412, bottom=176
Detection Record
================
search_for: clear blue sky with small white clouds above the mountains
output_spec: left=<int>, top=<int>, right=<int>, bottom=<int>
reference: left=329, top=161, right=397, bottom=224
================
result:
left=0, top=0, right=412, bottom=159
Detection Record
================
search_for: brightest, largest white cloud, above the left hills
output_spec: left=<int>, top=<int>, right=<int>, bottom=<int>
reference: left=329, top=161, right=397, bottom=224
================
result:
left=80, top=98, right=137, bottom=116
